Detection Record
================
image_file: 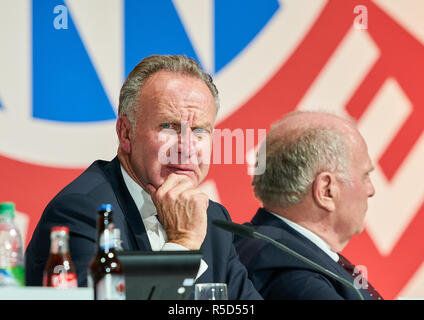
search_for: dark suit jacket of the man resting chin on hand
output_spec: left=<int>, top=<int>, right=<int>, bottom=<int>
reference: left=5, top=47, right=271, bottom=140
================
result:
left=25, top=158, right=262, bottom=299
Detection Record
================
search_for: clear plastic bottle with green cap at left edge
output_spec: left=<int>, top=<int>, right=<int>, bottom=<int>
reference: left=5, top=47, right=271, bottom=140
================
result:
left=0, top=202, right=25, bottom=286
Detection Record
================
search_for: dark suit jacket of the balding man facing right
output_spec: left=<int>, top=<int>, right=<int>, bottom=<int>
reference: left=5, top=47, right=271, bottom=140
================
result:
left=235, top=209, right=373, bottom=300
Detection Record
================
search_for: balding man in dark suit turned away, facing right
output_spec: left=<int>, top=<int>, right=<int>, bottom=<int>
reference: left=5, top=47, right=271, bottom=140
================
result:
left=236, top=112, right=382, bottom=299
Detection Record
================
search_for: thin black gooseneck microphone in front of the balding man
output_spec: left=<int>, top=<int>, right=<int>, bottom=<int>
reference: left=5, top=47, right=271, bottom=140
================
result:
left=212, top=220, right=364, bottom=300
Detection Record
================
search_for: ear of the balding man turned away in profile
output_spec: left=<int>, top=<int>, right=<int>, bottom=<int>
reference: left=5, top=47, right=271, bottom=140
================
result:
left=312, top=171, right=339, bottom=212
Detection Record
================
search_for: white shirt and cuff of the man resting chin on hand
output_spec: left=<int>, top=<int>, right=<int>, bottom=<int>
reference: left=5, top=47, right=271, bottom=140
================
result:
left=121, top=165, right=208, bottom=279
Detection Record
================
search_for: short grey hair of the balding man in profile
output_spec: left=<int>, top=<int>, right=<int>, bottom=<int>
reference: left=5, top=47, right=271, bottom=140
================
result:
left=252, top=127, right=351, bottom=208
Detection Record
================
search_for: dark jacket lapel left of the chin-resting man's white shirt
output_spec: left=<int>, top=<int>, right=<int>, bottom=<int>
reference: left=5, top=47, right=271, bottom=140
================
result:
left=105, top=157, right=152, bottom=251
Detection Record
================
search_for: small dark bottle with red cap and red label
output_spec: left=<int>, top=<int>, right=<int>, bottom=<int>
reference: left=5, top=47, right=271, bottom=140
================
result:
left=43, top=226, right=78, bottom=289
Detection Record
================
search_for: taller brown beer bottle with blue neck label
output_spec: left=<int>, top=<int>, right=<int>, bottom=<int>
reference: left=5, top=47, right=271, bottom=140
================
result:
left=88, top=204, right=125, bottom=300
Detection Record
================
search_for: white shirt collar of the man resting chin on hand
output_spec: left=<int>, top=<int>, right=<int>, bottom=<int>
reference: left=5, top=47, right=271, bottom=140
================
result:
left=121, top=164, right=156, bottom=219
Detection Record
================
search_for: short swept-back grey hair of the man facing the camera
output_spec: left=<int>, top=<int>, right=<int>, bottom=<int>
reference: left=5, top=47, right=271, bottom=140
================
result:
left=118, top=55, right=219, bottom=127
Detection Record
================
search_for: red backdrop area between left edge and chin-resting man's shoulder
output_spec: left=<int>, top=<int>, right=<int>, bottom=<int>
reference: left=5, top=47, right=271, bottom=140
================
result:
left=0, top=155, right=84, bottom=246
